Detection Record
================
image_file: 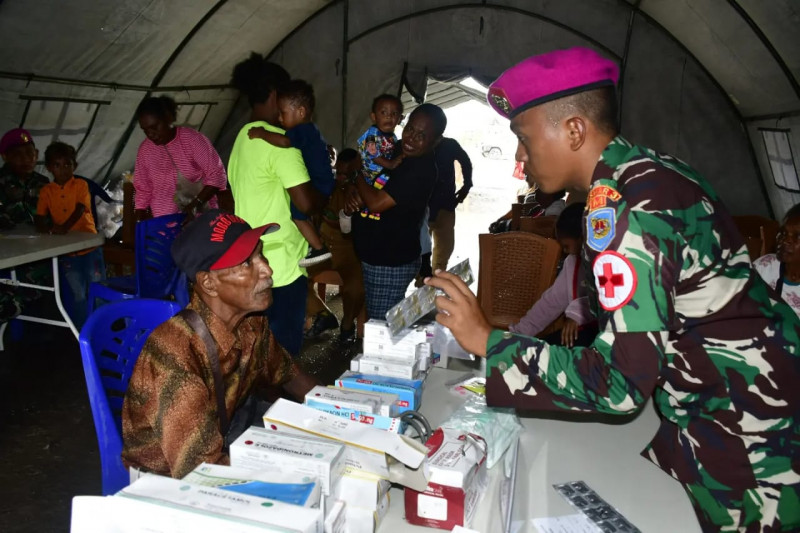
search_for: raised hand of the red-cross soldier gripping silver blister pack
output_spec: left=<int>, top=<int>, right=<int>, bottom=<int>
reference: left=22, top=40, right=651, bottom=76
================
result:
left=425, top=270, right=492, bottom=357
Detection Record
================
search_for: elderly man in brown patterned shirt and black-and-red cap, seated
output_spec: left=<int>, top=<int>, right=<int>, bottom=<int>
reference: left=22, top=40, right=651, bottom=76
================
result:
left=122, top=210, right=318, bottom=478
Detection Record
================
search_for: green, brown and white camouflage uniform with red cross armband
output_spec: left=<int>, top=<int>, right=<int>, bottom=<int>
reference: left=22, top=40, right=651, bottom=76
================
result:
left=487, top=137, right=800, bottom=531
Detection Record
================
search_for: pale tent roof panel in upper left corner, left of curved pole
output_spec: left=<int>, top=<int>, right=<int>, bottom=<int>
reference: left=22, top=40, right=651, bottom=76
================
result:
left=0, top=0, right=216, bottom=85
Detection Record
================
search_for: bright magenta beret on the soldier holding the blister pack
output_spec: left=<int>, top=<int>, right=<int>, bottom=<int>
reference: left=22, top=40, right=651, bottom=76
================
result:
left=486, top=47, right=619, bottom=119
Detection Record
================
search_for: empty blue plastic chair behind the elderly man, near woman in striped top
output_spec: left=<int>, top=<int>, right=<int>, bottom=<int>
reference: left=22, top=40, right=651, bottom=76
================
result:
left=89, top=213, right=186, bottom=314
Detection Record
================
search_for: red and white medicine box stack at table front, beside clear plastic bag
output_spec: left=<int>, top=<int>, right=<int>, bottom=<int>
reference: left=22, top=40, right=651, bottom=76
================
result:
left=405, top=428, right=487, bottom=531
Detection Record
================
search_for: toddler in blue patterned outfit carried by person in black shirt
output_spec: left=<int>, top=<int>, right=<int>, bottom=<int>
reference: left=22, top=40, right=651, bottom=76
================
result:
left=358, top=94, right=403, bottom=219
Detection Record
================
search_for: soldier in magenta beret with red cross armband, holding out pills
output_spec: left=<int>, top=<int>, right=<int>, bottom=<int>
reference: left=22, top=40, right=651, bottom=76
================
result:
left=429, top=48, right=800, bottom=531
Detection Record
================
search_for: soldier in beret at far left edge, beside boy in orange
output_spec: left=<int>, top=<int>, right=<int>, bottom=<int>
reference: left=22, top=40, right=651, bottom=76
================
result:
left=0, top=128, right=50, bottom=323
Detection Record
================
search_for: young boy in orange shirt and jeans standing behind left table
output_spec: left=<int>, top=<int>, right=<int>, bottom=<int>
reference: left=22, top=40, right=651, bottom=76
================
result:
left=35, top=142, right=105, bottom=328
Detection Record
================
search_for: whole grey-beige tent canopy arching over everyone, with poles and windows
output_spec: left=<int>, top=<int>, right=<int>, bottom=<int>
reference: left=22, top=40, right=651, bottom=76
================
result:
left=0, top=0, right=800, bottom=216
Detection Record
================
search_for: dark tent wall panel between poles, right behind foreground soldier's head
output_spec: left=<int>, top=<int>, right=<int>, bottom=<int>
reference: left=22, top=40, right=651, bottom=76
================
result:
left=621, top=17, right=770, bottom=216
